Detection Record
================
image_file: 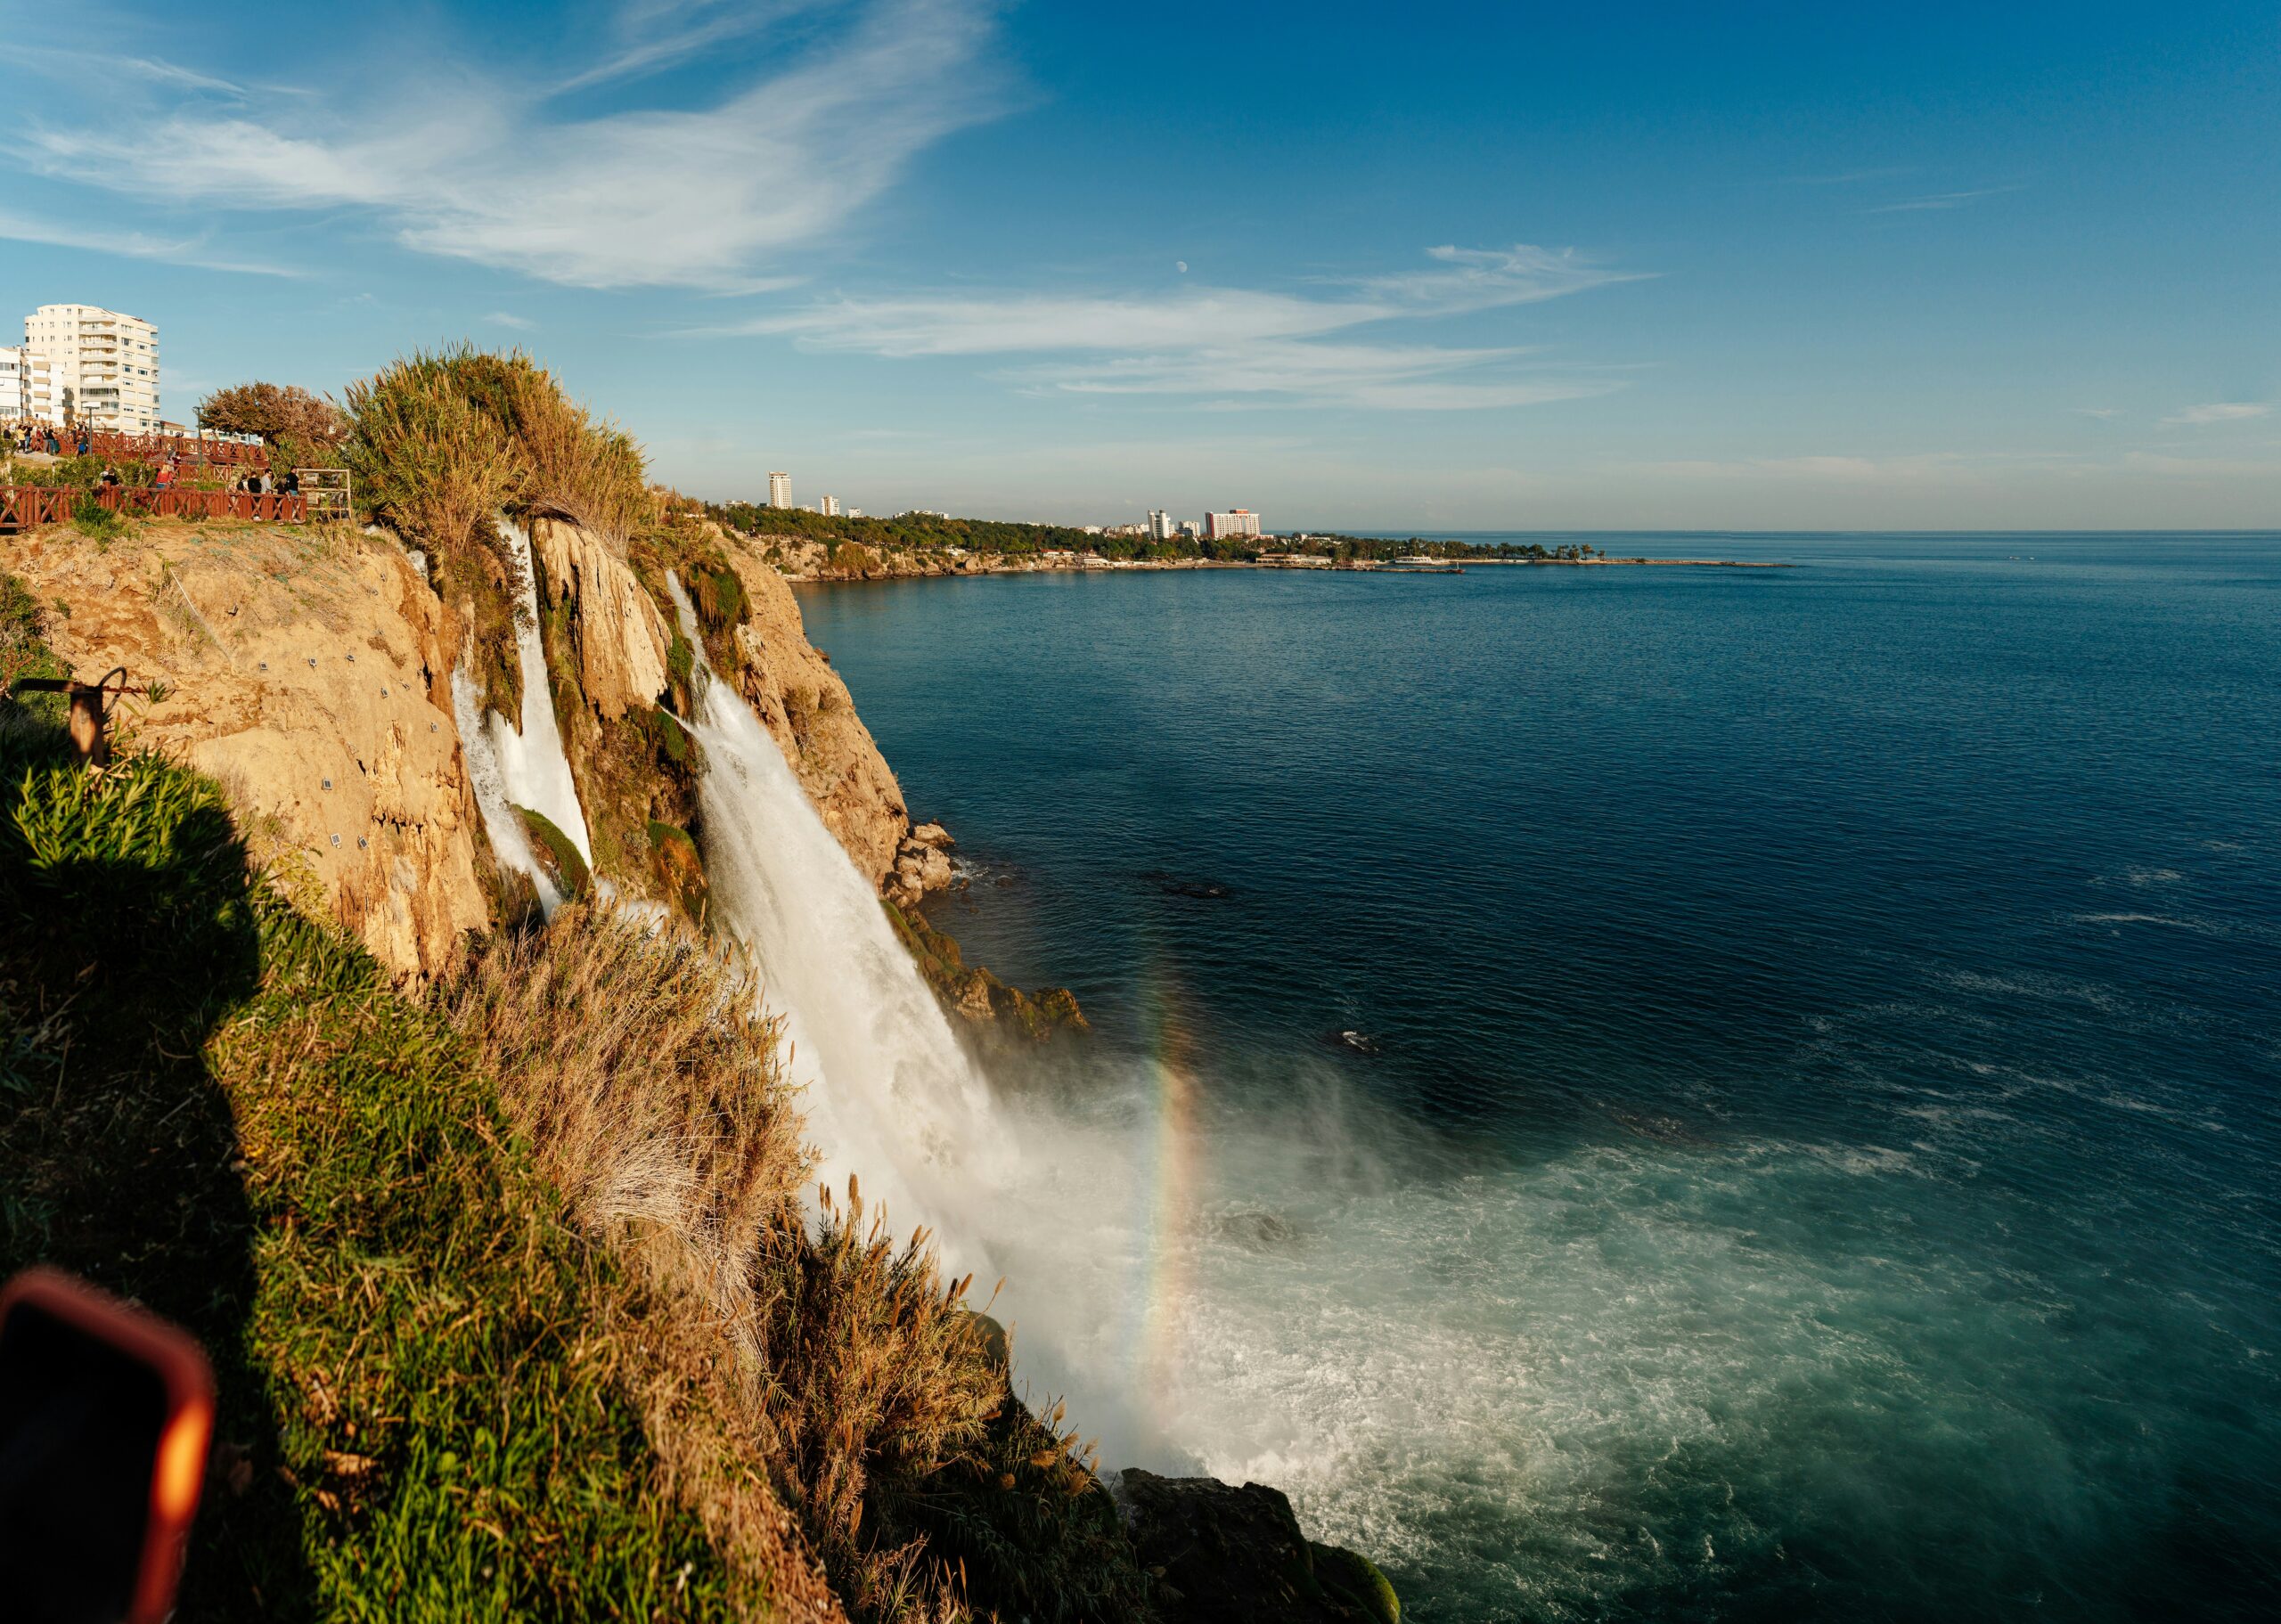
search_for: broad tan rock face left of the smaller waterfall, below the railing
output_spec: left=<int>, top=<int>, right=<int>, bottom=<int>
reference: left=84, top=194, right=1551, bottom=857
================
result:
left=7, top=525, right=488, bottom=978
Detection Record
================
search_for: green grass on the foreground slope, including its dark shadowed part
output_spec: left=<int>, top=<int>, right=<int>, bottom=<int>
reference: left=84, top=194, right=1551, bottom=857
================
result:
left=0, top=730, right=730, bottom=1620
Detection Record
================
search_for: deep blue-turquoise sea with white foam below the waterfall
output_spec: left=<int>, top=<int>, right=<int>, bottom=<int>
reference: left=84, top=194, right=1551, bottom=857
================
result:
left=801, top=536, right=2281, bottom=1621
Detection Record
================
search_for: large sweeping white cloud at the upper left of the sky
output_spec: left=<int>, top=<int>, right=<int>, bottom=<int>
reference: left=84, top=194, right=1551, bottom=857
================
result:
left=28, top=0, right=1003, bottom=290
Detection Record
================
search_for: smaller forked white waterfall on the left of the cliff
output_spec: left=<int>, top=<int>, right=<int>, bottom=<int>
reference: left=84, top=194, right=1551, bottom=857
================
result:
left=452, top=516, right=593, bottom=915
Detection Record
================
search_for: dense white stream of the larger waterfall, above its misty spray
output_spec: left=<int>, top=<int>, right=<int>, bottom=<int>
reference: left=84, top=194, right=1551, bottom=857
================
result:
left=671, top=582, right=1009, bottom=1279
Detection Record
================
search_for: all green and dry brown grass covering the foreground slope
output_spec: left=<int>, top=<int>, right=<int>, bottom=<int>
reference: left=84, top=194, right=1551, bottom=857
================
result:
left=0, top=693, right=1148, bottom=1620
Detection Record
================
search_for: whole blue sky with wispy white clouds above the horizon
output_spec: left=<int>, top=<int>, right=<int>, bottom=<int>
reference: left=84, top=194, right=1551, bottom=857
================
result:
left=0, top=0, right=2281, bottom=529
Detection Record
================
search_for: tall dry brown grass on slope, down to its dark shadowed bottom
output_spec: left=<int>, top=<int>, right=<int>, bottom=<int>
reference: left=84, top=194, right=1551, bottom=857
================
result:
left=447, top=908, right=1148, bottom=1624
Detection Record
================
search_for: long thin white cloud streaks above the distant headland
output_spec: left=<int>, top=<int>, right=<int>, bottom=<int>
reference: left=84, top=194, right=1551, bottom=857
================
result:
left=707, top=244, right=1642, bottom=411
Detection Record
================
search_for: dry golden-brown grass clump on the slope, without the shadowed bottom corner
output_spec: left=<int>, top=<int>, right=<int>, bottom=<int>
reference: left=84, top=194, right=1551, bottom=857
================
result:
left=443, top=905, right=1006, bottom=1624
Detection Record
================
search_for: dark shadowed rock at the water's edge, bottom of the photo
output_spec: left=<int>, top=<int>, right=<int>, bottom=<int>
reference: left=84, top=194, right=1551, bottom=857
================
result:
left=1117, top=1466, right=1401, bottom=1624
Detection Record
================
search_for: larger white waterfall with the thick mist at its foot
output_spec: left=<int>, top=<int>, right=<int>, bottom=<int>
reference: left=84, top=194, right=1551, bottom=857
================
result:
left=668, top=577, right=1200, bottom=1471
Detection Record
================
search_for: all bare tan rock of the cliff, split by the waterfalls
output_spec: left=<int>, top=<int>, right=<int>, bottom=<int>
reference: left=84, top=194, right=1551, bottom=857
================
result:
left=0, top=518, right=952, bottom=978
